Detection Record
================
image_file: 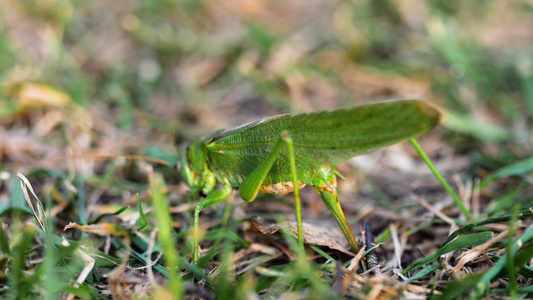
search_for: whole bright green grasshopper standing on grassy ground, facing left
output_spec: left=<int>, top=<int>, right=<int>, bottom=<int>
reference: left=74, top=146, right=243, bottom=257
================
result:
left=179, top=100, right=440, bottom=263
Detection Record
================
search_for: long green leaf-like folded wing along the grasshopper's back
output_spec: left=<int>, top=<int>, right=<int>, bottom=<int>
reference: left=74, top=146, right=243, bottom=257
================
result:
left=206, top=100, right=440, bottom=184
